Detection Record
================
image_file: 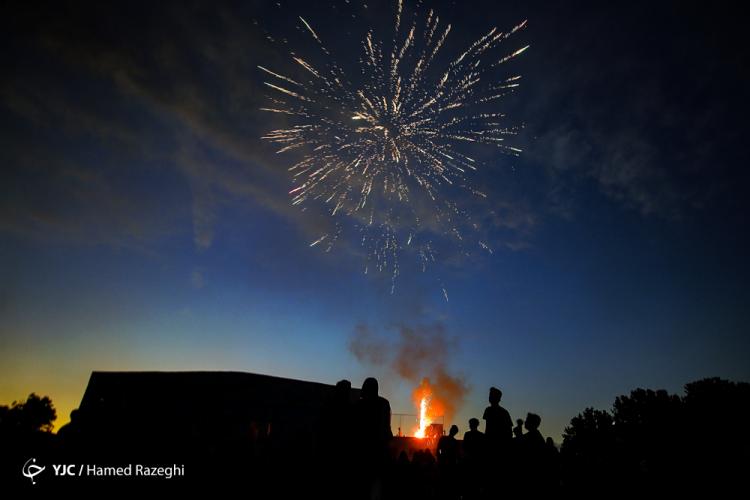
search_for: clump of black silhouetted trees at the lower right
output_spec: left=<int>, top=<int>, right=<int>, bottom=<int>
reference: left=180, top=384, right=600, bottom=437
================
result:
left=561, top=378, right=750, bottom=493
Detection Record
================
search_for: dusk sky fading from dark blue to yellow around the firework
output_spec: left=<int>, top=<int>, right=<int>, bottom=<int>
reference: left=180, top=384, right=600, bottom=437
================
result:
left=0, top=0, right=750, bottom=440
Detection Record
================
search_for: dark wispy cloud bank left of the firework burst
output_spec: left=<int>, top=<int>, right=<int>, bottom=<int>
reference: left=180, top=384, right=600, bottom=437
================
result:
left=0, top=2, right=318, bottom=254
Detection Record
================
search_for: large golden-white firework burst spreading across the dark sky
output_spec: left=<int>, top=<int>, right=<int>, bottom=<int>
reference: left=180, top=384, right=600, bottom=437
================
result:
left=258, top=0, right=529, bottom=300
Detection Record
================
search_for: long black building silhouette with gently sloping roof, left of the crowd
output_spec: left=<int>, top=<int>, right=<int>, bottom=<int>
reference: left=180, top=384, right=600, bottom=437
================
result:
left=80, top=371, right=359, bottom=458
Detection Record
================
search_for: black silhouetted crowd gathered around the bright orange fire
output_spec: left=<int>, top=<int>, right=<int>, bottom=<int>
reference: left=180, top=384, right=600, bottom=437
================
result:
left=319, top=378, right=560, bottom=500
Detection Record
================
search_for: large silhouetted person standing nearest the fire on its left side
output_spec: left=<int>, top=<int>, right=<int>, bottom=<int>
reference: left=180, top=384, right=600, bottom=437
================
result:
left=354, top=377, right=393, bottom=498
